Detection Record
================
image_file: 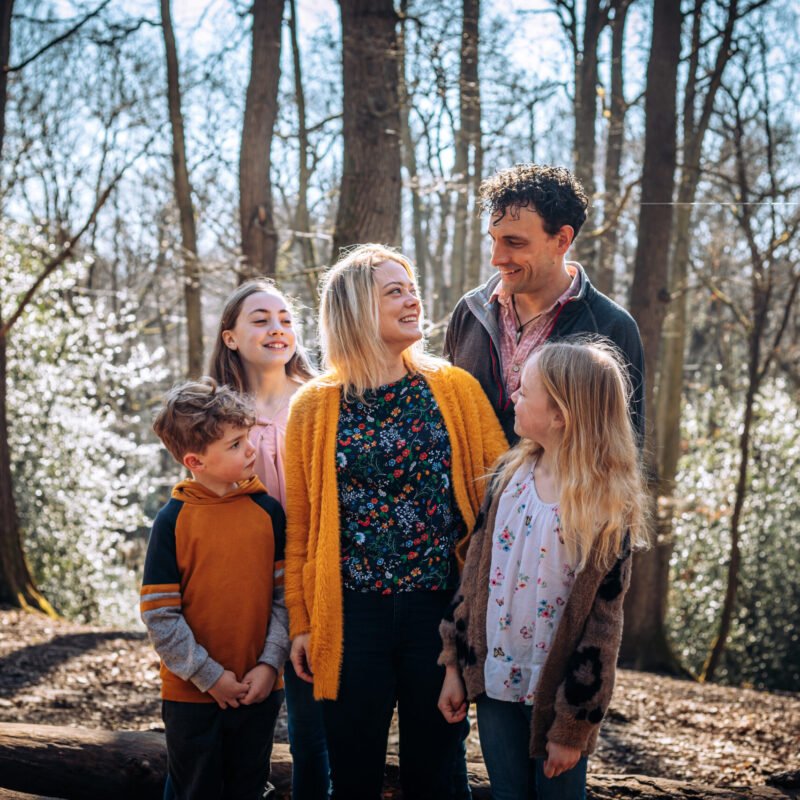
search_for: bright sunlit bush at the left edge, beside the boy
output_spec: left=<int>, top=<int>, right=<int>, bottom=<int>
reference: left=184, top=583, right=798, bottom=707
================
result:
left=0, top=227, right=162, bottom=623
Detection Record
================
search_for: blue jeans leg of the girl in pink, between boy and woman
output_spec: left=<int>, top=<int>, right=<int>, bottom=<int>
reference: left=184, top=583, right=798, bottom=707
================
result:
left=283, top=661, right=331, bottom=800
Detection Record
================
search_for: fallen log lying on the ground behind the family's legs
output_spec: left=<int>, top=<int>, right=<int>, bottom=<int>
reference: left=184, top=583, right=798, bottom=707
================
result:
left=0, top=723, right=797, bottom=800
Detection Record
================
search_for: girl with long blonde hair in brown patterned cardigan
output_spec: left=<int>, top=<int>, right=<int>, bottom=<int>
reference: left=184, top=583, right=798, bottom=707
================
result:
left=439, top=342, right=646, bottom=800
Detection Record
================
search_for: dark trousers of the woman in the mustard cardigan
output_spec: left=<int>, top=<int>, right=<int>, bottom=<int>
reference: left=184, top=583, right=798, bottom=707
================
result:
left=323, top=591, right=462, bottom=800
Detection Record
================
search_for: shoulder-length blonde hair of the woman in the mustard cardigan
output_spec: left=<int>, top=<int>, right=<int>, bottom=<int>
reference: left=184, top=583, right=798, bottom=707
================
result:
left=319, top=244, right=445, bottom=400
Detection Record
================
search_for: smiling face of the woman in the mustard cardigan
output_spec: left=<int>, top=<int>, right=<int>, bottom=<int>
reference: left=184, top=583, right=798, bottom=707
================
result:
left=372, top=261, right=422, bottom=355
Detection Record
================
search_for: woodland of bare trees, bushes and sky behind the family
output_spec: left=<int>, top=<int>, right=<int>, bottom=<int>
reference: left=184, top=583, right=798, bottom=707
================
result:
left=0, top=0, right=800, bottom=691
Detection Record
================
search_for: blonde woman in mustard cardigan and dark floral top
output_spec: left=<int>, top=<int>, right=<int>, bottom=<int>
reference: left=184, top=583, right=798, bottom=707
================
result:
left=286, top=245, right=507, bottom=800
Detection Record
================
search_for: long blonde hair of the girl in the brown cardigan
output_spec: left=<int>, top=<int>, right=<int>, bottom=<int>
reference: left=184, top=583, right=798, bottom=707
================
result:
left=493, top=339, right=648, bottom=570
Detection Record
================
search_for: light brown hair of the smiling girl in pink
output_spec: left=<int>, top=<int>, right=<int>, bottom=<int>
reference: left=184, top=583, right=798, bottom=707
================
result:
left=208, top=278, right=316, bottom=394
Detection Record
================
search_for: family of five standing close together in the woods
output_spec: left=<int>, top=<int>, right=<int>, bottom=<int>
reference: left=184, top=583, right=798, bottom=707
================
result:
left=141, top=164, right=646, bottom=800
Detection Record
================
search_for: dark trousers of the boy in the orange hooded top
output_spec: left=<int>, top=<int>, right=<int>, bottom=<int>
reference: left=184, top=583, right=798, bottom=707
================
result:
left=161, top=690, right=283, bottom=800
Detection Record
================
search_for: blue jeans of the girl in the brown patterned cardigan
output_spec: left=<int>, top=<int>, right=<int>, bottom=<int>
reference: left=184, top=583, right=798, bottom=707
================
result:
left=476, top=694, right=586, bottom=800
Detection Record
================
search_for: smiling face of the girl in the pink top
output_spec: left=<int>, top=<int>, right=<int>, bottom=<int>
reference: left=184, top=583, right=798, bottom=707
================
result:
left=222, top=292, right=297, bottom=369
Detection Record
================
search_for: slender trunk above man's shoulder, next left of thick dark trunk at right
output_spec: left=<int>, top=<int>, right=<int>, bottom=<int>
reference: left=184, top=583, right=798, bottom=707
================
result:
left=590, top=0, right=632, bottom=295
